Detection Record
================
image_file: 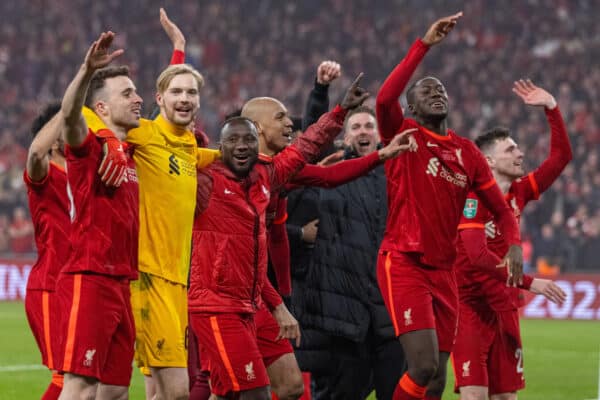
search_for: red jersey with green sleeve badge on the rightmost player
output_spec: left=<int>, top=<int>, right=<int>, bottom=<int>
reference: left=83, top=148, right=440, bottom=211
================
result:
left=455, top=173, right=539, bottom=311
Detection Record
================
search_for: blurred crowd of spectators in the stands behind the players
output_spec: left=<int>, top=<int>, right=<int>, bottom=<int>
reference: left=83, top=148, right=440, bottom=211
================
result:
left=0, top=0, right=600, bottom=271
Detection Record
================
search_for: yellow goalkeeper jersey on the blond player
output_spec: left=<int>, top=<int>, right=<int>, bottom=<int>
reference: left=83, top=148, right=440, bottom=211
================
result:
left=84, top=109, right=220, bottom=285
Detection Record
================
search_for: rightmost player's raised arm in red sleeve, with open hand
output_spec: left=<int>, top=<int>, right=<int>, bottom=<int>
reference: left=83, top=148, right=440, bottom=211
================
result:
left=513, top=80, right=573, bottom=199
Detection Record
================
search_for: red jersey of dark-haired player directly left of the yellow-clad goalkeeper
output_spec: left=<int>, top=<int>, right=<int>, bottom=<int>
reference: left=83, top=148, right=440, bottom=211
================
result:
left=63, top=130, right=138, bottom=279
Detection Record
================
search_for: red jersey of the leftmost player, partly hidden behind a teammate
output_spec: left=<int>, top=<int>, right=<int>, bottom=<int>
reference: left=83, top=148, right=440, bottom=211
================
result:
left=23, top=162, right=71, bottom=291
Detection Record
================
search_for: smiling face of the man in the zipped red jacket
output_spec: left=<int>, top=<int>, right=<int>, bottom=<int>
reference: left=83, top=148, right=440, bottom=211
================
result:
left=221, top=122, right=258, bottom=177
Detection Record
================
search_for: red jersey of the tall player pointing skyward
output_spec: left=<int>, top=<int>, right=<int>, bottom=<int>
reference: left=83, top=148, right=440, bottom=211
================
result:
left=381, top=124, right=495, bottom=269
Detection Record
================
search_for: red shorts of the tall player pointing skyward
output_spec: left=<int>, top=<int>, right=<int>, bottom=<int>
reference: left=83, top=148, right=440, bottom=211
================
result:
left=377, top=251, right=458, bottom=352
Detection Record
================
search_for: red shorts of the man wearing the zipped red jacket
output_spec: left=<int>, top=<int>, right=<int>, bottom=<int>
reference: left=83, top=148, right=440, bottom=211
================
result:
left=190, top=313, right=269, bottom=397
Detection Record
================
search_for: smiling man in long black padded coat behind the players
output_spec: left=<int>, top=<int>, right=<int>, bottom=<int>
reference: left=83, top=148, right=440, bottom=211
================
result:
left=292, top=107, right=405, bottom=399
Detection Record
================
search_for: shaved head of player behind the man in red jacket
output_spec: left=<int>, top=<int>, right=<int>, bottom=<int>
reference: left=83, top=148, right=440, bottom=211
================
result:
left=242, top=97, right=292, bottom=156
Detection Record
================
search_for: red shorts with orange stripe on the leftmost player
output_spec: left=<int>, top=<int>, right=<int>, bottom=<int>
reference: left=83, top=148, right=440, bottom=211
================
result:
left=25, top=290, right=64, bottom=369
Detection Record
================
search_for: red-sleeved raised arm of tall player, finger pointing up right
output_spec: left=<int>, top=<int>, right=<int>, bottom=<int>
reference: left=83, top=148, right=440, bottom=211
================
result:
left=375, top=12, right=462, bottom=143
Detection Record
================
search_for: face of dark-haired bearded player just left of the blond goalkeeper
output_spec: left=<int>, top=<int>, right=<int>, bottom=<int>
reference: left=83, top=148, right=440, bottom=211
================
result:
left=103, top=76, right=142, bottom=130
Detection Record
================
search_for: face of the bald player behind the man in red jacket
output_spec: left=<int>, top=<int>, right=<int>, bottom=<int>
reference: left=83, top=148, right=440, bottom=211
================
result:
left=256, top=99, right=293, bottom=154
